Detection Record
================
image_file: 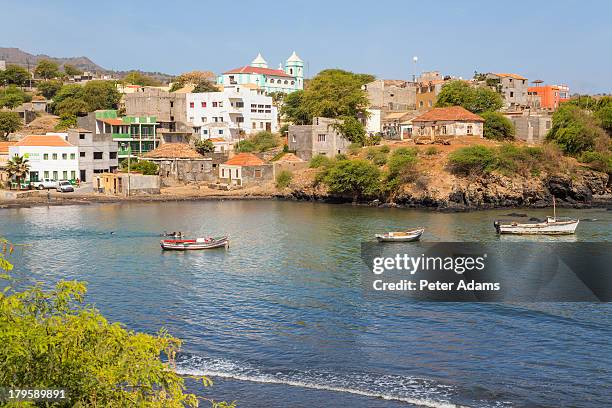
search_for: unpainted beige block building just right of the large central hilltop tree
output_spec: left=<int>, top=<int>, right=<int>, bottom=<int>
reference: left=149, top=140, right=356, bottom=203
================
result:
left=363, top=79, right=416, bottom=113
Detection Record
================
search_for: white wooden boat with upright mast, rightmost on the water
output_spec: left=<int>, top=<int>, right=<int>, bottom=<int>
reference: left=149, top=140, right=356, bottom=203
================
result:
left=493, top=197, right=580, bottom=235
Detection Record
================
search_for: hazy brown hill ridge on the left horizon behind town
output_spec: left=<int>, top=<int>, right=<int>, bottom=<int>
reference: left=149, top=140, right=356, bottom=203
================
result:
left=0, top=47, right=173, bottom=82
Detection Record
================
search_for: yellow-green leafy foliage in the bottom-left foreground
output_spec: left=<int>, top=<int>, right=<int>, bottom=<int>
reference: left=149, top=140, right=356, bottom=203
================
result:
left=0, top=239, right=235, bottom=408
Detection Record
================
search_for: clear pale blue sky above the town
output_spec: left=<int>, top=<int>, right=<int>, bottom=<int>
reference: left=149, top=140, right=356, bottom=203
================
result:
left=0, top=0, right=612, bottom=93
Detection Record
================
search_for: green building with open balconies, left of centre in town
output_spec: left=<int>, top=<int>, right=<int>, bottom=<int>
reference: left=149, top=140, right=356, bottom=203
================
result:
left=77, top=110, right=160, bottom=159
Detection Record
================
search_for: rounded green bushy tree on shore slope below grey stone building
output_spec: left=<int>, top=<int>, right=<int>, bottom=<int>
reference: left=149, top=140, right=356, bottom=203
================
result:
left=323, top=159, right=380, bottom=202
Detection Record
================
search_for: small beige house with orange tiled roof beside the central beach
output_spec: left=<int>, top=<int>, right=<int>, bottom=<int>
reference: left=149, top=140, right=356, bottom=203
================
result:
left=219, top=153, right=274, bottom=187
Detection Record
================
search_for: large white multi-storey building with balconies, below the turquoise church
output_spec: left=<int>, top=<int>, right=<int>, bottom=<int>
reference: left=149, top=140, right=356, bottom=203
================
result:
left=186, top=85, right=278, bottom=142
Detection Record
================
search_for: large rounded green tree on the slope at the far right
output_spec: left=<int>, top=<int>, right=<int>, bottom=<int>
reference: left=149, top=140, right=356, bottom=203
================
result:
left=546, top=104, right=610, bottom=155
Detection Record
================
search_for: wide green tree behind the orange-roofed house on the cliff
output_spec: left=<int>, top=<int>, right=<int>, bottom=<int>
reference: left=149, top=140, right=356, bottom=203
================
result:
left=436, top=81, right=503, bottom=114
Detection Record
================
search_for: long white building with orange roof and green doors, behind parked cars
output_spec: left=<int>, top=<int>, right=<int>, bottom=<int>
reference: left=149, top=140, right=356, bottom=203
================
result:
left=9, top=135, right=79, bottom=181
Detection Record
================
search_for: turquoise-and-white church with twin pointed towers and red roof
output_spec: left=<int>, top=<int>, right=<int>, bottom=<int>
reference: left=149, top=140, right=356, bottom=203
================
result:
left=217, top=51, right=304, bottom=93
